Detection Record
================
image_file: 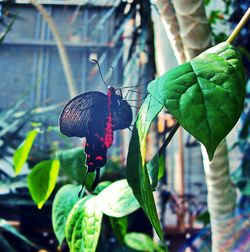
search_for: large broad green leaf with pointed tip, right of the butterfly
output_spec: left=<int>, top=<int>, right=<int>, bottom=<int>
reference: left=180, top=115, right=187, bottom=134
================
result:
left=148, top=42, right=246, bottom=160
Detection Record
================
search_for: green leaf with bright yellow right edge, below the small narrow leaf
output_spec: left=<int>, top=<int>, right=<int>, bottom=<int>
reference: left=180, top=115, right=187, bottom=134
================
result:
left=28, top=160, right=60, bottom=209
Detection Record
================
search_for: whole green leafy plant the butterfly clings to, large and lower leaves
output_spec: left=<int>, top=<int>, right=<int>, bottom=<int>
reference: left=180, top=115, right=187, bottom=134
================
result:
left=15, top=7, right=248, bottom=252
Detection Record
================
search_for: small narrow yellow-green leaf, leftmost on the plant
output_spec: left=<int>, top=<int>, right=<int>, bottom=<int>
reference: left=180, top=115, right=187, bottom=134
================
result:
left=13, top=130, right=38, bottom=175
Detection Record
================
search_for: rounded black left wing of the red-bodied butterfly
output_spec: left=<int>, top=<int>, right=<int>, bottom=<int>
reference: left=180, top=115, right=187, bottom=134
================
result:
left=59, top=91, right=108, bottom=137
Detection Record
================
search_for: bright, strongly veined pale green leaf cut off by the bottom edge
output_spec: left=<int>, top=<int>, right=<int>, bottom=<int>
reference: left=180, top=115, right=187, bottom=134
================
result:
left=65, top=196, right=103, bottom=252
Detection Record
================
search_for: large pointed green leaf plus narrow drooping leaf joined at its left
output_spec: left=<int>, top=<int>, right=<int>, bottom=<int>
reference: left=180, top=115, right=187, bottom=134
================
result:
left=127, top=40, right=245, bottom=246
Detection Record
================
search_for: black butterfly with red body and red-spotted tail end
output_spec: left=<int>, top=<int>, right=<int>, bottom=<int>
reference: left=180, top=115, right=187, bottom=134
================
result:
left=59, top=61, right=132, bottom=191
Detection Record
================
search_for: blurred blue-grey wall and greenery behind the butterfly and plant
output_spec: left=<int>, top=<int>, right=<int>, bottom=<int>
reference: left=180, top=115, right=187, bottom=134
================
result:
left=0, top=0, right=250, bottom=251
